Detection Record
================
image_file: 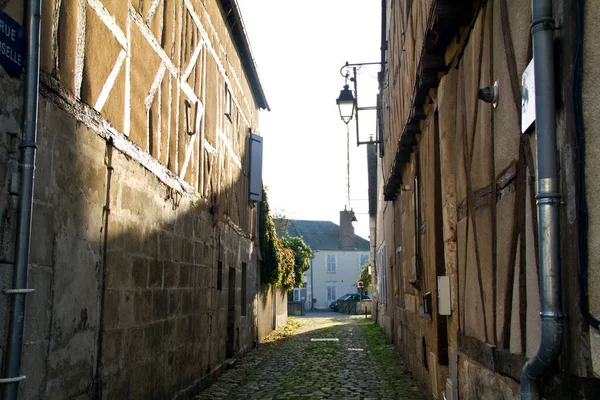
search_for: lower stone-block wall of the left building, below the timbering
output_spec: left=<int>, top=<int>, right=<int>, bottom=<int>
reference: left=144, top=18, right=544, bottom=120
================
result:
left=0, top=71, right=284, bottom=398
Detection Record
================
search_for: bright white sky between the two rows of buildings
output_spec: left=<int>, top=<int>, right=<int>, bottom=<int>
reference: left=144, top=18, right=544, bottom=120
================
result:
left=238, top=0, right=381, bottom=239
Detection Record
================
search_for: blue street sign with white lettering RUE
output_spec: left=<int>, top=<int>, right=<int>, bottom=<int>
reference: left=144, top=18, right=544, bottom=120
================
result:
left=0, top=10, right=25, bottom=76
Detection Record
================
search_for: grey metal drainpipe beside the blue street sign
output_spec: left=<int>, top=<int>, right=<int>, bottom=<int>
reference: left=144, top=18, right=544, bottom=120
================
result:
left=0, top=0, right=42, bottom=400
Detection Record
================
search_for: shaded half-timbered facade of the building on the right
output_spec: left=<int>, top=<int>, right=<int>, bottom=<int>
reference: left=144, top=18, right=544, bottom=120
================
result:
left=371, top=0, right=600, bottom=400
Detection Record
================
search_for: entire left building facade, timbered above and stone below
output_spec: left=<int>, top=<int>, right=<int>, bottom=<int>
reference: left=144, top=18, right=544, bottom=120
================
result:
left=0, top=0, right=287, bottom=399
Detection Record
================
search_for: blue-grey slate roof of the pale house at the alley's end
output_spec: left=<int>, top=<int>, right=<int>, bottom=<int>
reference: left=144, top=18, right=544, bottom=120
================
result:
left=277, top=220, right=369, bottom=251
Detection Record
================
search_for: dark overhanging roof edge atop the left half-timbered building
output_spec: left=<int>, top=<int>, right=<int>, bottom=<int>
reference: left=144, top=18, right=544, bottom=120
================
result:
left=220, top=0, right=271, bottom=111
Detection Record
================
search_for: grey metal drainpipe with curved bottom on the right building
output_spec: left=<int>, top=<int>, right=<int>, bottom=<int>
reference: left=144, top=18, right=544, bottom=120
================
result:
left=521, top=0, right=563, bottom=399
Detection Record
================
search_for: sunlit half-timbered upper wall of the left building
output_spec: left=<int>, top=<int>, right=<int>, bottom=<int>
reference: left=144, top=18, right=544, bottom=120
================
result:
left=5, top=0, right=258, bottom=230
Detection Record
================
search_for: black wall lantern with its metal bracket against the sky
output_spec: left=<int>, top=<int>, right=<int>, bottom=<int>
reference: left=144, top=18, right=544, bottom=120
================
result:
left=336, top=61, right=381, bottom=146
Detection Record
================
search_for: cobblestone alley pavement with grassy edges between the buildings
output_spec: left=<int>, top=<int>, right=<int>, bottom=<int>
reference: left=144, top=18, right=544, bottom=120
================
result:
left=197, top=312, right=423, bottom=400
